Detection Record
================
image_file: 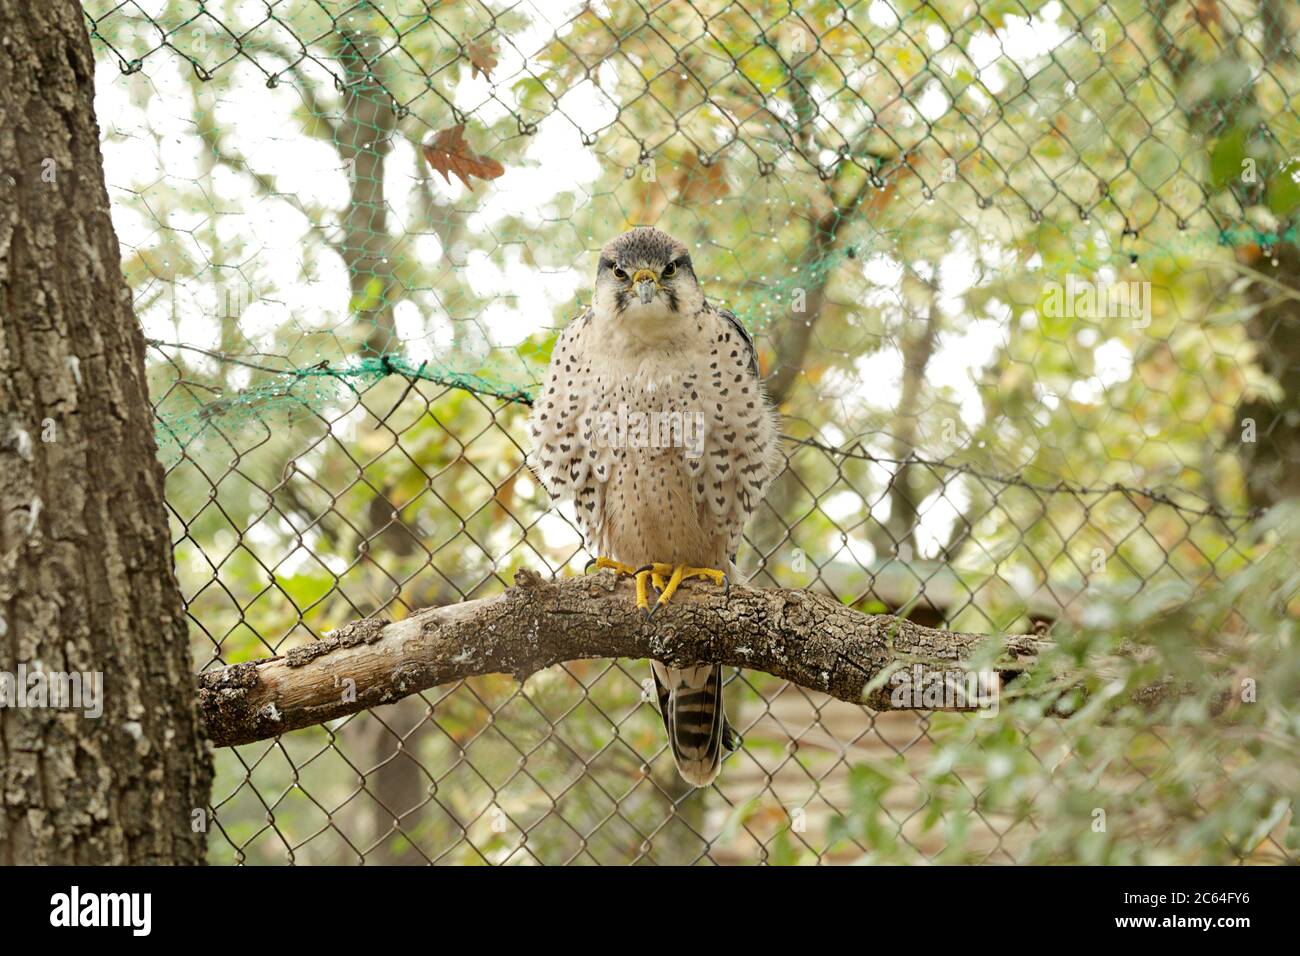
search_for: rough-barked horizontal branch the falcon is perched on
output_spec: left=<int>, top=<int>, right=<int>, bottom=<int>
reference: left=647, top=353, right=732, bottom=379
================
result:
left=199, top=571, right=1043, bottom=747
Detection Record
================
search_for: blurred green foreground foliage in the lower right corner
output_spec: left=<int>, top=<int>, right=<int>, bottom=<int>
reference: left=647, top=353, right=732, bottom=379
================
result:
left=828, top=506, right=1300, bottom=865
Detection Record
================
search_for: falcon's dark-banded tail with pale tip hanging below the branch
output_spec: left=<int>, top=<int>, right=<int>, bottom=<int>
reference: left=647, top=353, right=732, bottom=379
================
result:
left=650, top=661, right=740, bottom=787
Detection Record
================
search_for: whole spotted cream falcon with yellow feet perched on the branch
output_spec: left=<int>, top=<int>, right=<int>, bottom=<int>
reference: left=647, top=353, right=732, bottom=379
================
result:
left=529, top=226, right=780, bottom=787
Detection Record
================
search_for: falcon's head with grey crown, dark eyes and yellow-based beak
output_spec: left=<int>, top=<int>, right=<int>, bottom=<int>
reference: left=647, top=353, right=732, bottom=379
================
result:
left=594, top=226, right=705, bottom=325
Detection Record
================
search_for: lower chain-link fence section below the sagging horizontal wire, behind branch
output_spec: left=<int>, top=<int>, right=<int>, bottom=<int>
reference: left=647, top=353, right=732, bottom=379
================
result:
left=157, top=346, right=1287, bottom=864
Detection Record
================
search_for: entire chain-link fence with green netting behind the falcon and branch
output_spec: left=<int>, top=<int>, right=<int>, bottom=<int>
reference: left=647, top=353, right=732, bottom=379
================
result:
left=85, top=0, right=1300, bottom=864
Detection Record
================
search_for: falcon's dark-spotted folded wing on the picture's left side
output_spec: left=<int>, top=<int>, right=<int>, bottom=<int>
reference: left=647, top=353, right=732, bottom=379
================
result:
left=529, top=310, right=610, bottom=542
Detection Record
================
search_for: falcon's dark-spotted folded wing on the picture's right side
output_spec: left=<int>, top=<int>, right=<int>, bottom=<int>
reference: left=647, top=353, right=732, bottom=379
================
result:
left=688, top=307, right=780, bottom=555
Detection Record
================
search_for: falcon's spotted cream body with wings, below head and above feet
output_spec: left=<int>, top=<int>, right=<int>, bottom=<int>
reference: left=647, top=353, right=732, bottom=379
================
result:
left=532, top=311, right=776, bottom=567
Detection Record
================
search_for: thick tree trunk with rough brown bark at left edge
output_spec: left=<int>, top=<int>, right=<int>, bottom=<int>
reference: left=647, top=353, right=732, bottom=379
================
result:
left=0, top=0, right=212, bottom=864
